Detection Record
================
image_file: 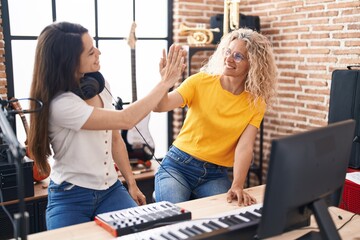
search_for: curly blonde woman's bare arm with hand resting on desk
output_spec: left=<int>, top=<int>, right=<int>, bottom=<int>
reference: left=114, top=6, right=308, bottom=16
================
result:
left=227, top=124, right=258, bottom=206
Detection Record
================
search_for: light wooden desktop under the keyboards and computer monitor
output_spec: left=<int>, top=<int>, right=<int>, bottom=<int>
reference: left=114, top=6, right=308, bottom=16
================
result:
left=28, top=185, right=360, bottom=240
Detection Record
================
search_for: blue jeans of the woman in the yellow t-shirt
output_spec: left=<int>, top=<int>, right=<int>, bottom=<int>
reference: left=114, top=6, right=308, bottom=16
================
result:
left=155, top=146, right=231, bottom=203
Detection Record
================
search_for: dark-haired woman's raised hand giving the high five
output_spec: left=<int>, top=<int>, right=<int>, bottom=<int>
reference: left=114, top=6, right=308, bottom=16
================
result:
left=159, top=45, right=186, bottom=88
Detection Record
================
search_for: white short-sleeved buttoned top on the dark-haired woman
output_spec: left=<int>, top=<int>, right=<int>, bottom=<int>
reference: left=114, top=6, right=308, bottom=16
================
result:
left=49, top=83, right=118, bottom=190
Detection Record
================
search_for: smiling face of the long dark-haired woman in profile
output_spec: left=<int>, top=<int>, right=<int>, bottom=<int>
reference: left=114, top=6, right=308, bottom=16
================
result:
left=79, top=33, right=101, bottom=75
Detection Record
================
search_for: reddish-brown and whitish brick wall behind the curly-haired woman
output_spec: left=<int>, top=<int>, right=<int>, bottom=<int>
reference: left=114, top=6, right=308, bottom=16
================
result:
left=174, top=0, right=360, bottom=186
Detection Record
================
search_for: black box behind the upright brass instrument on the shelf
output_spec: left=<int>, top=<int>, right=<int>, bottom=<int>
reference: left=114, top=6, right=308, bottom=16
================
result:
left=210, top=13, right=260, bottom=44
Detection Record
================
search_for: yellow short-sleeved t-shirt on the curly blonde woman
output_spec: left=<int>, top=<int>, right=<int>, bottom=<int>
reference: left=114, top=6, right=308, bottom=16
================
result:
left=173, top=72, right=266, bottom=167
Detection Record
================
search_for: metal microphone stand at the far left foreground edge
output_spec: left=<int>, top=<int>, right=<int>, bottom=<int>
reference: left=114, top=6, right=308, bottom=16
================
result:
left=0, top=103, right=29, bottom=240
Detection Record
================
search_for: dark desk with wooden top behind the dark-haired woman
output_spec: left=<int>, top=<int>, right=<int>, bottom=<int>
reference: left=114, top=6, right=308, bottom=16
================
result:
left=0, top=161, right=159, bottom=239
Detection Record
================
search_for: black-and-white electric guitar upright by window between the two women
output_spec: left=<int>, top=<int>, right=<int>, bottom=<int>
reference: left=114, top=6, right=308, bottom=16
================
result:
left=115, top=22, right=155, bottom=167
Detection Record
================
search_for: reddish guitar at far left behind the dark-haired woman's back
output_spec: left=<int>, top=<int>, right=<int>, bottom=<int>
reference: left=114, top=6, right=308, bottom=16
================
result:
left=9, top=98, right=50, bottom=182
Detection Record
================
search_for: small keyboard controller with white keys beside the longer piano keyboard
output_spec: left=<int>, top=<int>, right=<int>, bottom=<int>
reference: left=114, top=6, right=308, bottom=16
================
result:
left=94, top=201, right=191, bottom=237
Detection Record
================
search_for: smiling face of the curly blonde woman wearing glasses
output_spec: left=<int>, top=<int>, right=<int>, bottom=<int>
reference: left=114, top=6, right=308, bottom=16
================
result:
left=223, top=39, right=250, bottom=77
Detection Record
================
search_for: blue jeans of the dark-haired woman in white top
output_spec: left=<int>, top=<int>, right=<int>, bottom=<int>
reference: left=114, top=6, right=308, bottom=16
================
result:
left=46, top=180, right=137, bottom=230
